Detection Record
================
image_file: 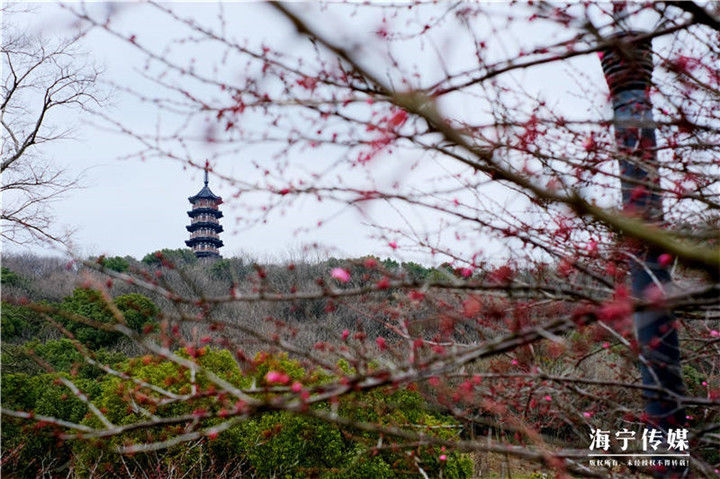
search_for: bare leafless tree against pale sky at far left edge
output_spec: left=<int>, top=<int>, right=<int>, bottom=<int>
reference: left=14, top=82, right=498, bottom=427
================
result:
left=0, top=20, right=99, bottom=244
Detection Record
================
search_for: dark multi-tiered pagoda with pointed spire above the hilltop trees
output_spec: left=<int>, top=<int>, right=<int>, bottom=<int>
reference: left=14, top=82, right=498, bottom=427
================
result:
left=185, top=162, right=223, bottom=258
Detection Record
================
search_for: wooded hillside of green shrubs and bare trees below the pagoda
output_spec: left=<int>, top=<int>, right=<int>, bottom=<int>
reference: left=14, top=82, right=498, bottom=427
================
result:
left=2, top=249, right=720, bottom=478
